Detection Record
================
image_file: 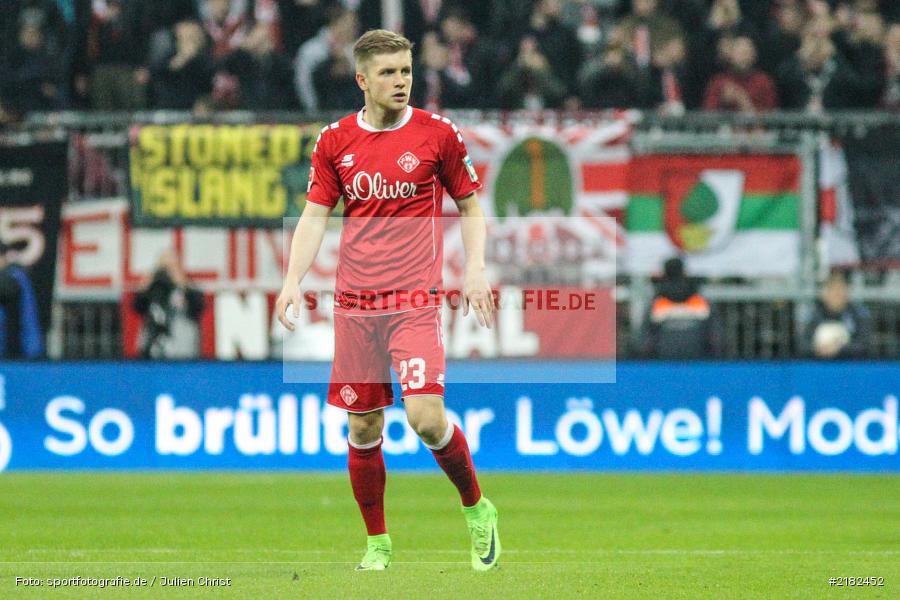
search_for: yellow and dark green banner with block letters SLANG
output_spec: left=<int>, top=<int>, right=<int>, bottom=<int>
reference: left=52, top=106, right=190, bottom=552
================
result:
left=129, top=124, right=322, bottom=227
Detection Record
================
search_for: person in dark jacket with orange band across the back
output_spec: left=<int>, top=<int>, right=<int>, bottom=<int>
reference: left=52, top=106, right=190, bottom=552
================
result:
left=638, top=258, right=716, bottom=360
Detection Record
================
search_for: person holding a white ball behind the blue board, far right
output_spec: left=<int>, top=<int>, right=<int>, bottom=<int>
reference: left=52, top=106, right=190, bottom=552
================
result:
left=801, top=273, right=872, bottom=359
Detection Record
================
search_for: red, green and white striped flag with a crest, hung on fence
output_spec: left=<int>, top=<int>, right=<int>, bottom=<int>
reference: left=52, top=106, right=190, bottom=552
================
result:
left=624, top=155, right=800, bottom=277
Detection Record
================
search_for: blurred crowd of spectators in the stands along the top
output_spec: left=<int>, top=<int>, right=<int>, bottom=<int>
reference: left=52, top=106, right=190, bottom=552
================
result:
left=0, top=0, right=900, bottom=122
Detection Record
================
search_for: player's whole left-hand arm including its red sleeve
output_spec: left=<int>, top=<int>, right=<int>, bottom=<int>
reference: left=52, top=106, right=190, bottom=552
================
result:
left=275, top=124, right=341, bottom=331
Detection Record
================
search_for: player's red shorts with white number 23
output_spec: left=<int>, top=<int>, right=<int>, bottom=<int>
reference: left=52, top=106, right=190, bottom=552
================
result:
left=328, top=307, right=444, bottom=413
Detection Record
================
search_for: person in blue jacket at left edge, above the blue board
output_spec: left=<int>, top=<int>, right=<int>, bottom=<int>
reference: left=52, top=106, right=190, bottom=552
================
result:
left=0, top=242, right=44, bottom=359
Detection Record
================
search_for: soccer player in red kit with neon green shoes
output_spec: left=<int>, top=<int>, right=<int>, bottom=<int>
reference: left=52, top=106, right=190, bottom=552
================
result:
left=275, top=29, right=500, bottom=571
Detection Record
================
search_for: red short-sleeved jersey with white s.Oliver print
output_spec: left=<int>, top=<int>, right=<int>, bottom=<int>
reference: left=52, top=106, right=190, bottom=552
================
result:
left=306, top=107, right=481, bottom=314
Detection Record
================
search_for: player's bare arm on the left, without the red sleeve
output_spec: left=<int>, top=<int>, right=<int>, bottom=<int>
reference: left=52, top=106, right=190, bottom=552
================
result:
left=275, top=202, right=331, bottom=331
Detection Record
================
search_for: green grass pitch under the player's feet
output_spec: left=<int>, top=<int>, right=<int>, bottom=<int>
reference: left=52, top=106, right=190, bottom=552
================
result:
left=0, top=472, right=900, bottom=600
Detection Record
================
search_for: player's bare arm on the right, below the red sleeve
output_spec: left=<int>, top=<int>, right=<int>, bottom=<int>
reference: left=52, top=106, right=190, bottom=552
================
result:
left=456, top=192, right=495, bottom=327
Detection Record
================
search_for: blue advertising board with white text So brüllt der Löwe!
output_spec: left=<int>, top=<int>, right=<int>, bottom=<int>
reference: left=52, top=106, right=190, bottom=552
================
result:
left=0, top=361, right=900, bottom=472
